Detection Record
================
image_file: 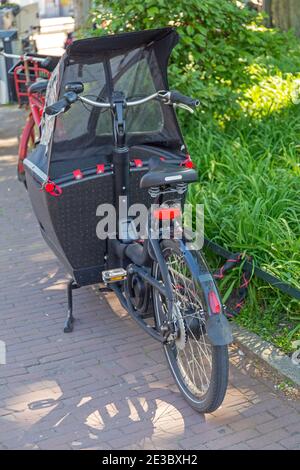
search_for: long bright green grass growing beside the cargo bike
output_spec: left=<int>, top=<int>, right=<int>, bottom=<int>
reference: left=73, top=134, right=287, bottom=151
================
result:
left=185, top=72, right=300, bottom=352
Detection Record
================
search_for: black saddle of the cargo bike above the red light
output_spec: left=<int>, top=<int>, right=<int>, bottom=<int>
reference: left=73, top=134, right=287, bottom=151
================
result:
left=140, top=158, right=198, bottom=189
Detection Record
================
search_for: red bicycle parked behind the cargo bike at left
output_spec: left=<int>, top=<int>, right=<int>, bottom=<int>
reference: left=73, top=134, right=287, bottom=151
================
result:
left=1, top=51, right=59, bottom=185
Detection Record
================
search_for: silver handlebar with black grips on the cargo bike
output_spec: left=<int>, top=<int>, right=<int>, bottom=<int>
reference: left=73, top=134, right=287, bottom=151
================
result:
left=45, top=90, right=200, bottom=116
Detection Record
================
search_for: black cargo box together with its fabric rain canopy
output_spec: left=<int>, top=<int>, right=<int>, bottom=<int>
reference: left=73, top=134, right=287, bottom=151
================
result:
left=25, top=28, right=190, bottom=285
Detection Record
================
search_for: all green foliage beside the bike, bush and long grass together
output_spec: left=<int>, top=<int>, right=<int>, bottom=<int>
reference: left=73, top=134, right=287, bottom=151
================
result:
left=87, top=0, right=300, bottom=351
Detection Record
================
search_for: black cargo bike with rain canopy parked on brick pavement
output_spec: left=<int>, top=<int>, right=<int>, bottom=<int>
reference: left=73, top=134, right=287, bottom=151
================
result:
left=24, top=28, right=232, bottom=412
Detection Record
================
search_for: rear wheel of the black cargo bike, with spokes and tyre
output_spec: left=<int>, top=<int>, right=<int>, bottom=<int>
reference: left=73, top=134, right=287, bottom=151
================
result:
left=153, top=240, right=229, bottom=413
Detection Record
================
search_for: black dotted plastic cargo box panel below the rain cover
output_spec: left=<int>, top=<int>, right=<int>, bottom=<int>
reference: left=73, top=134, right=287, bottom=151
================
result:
left=26, top=146, right=182, bottom=285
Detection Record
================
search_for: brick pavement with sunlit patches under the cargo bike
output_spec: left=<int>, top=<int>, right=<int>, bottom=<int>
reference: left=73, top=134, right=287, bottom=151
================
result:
left=0, top=107, right=300, bottom=449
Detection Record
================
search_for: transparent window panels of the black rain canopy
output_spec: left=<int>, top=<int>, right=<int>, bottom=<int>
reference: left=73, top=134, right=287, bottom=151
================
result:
left=49, top=37, right=183, bottom=178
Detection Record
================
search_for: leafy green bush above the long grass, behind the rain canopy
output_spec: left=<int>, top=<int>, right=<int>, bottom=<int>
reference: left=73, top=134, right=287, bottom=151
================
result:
left=91, top=0, right=300, bottom=114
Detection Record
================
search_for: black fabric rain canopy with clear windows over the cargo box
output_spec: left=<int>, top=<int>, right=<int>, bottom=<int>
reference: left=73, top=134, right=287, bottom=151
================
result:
left=35, top=28, right=184, bottom=179
